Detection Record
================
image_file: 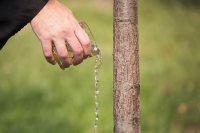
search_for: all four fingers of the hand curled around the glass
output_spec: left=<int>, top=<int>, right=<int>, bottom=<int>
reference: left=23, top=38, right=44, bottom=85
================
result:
left=42, top=26, right=91, bottom=68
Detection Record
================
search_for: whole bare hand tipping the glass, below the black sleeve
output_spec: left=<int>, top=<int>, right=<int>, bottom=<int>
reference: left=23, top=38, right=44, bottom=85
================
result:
left=31, top=0, right=91, bottom=68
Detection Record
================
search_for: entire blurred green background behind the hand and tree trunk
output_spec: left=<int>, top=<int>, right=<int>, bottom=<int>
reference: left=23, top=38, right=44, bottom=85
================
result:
left=0, top=0, right=200, bottom=133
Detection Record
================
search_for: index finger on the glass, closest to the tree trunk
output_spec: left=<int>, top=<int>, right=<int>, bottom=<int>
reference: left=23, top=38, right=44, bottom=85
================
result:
left=75, top=25, right=92, bottom=57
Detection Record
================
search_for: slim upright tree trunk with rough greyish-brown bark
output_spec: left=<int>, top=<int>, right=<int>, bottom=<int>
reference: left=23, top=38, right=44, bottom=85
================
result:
left=113, top=0, right=141, bottom=133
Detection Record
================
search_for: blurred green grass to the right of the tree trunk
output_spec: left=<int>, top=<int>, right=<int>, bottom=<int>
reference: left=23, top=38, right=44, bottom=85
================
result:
left=139, top=1, right=200, bottom=133
